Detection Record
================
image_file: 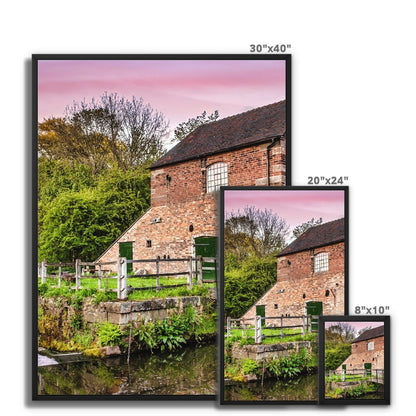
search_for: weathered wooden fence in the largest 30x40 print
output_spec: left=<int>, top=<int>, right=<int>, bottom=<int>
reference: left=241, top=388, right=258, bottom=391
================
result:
left=38, top=256, right=217, bottom=300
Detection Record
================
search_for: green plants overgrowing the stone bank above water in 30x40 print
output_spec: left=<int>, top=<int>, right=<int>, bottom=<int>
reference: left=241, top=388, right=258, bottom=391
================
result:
left=38, top=297, right=217, bottom=357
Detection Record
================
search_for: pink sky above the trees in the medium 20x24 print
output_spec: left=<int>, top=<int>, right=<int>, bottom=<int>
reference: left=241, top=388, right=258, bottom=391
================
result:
left=224, top=189, right=344, bottom=231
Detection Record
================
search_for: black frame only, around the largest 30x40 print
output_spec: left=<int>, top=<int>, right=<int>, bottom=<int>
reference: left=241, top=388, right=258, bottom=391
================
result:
left=31, top=53, right=292, bottom=401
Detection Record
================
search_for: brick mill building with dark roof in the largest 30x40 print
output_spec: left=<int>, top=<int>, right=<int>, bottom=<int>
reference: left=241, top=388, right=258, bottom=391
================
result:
left=97, top=101, right=286, bottom=272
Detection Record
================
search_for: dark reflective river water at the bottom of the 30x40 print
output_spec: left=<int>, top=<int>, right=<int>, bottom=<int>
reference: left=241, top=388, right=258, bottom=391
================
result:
left=38, top=344, right=217, bottom=395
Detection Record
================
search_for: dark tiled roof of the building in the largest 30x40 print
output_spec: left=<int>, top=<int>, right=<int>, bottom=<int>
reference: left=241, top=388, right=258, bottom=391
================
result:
left=150, top=100, right=286, bottom=169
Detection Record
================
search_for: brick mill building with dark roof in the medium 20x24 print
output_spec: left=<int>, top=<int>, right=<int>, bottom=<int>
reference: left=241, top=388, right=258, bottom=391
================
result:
left=242, top=218, right=345, bottom=325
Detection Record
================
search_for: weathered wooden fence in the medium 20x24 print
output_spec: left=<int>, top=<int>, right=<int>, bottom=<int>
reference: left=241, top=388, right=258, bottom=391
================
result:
left=226, top=315, right=318, bottom=344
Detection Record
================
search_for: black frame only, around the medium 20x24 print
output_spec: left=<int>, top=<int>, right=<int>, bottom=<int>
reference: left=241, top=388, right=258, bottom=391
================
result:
left=218, top=186, right=349, bottom=406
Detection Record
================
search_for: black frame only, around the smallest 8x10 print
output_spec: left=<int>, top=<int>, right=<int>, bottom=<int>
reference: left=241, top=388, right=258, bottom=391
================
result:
left=318, top=315, right=391, bottom=406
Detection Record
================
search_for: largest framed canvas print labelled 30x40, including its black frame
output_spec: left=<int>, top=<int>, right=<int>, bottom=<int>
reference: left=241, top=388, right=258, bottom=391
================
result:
left=33, top=55, right=291, bottom=400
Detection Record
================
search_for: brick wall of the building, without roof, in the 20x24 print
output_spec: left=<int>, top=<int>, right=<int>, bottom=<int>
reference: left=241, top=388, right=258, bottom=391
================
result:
left=242, top=243, right=345, bottom=324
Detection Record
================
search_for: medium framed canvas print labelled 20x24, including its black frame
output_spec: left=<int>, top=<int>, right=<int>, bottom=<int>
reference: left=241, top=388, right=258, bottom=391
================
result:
left=220, top=186, right=348, bottom=405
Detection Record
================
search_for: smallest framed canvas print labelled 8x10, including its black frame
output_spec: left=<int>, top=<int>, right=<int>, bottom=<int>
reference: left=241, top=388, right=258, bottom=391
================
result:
left=319, top=316, right=390, bottom=405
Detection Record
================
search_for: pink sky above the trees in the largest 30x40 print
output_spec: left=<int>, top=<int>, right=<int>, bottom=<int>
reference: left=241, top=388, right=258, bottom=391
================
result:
left=38, top=60, right=285, bottom=130
